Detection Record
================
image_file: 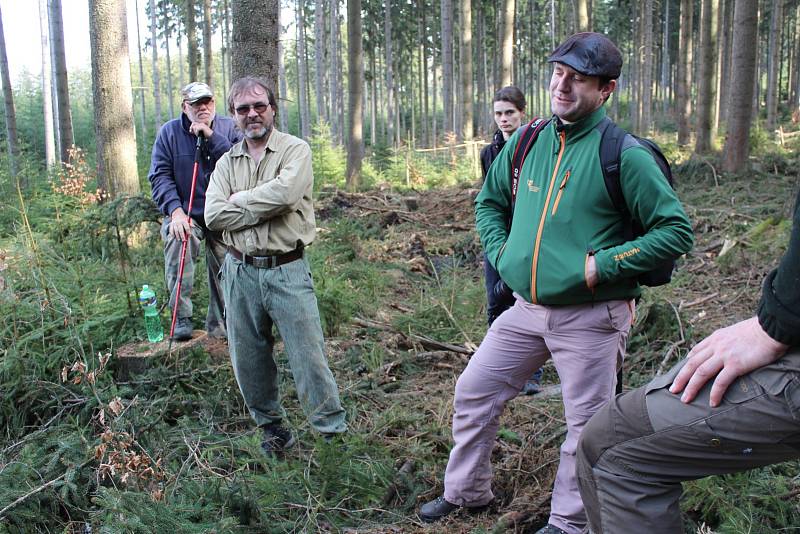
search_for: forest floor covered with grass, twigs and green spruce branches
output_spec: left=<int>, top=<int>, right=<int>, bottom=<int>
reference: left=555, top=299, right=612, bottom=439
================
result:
left=0, top=141, right=800, bottom=533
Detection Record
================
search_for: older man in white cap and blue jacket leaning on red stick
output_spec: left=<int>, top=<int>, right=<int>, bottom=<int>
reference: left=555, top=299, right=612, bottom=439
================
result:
left=147, top=82, right=242, bottom=341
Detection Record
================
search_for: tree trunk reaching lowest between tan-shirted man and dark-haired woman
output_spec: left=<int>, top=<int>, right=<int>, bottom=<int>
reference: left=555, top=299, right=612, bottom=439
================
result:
left=346, top=0, right=364, bottom=191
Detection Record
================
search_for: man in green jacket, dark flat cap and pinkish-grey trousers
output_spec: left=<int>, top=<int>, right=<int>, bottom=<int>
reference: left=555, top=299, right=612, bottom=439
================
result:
left=419, top=33, right=693, bottom=534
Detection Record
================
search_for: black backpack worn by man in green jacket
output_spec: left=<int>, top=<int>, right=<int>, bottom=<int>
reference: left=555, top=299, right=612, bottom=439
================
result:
left=511, top=117, right=675, bottom=287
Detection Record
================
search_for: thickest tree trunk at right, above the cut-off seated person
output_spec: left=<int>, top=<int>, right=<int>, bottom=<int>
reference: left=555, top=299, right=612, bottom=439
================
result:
left=722, top=0, right=758, bottom=172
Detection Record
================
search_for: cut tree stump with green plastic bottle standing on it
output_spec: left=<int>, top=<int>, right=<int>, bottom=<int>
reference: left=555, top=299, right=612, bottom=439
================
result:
left=117, top=330, right=228, bottom=382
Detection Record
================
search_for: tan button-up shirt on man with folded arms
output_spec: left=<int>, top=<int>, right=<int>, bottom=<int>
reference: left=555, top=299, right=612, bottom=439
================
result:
left=205, top=129, right=316, bottom=256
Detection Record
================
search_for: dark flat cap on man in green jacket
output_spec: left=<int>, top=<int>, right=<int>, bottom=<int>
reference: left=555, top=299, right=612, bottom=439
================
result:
left=547, top=32, right=622, bottom=80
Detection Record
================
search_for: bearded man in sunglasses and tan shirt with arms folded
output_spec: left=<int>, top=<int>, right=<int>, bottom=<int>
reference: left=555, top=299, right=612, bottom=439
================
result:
left=205, top=77, right=347, bottom=455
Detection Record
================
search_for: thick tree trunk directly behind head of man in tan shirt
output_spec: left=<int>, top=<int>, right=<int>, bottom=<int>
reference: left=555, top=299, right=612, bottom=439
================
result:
left=231, top=0, right=281, bottom=92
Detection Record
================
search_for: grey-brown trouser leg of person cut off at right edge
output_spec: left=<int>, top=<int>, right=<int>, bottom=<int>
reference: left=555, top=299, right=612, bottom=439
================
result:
left=577, top=350, right=800, bottom=534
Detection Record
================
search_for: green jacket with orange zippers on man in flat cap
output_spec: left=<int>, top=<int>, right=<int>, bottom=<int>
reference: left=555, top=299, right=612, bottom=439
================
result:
left=475, top=107, right=694, bottom=306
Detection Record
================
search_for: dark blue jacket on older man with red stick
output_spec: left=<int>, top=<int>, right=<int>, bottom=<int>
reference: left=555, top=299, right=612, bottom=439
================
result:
left=147, top=113, right=242, bottom=226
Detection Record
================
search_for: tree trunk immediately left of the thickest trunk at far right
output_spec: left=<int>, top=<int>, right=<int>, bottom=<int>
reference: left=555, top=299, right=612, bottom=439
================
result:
left=694, top=0, right=717, bottom=154
